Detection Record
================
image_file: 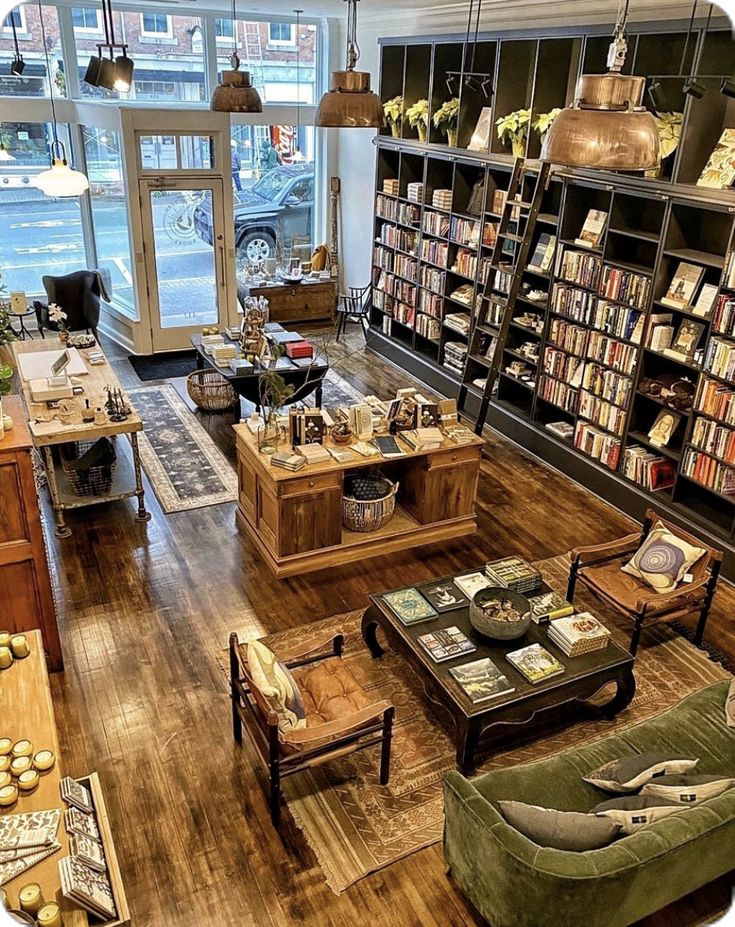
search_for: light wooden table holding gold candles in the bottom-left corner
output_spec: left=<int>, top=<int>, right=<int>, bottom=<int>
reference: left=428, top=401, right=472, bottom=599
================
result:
left=0, top=631, right=130, bottom=927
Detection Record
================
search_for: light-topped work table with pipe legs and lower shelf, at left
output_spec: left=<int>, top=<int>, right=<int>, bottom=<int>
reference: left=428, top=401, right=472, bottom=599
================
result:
left=13, top=337, right=151, bottom=538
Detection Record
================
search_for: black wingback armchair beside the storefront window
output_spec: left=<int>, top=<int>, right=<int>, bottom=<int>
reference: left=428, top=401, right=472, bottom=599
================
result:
left=33, top=270, right=112, bottom=338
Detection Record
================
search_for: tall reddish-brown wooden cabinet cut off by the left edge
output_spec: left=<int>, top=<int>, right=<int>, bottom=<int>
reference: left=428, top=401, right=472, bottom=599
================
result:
left=0, top=396, right=63, bottom=670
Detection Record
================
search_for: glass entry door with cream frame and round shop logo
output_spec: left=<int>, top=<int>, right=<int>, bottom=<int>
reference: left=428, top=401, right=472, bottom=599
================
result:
left=140, top=176, right=227, bottom=352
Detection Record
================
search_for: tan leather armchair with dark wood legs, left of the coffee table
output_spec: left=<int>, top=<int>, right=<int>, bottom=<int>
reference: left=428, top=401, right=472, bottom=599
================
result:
left=230, top=634, right=395, bottom=829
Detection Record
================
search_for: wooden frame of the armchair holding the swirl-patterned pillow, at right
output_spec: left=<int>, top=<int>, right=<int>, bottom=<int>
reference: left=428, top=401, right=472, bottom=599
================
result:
left=567, top=509, right=723, bottom=655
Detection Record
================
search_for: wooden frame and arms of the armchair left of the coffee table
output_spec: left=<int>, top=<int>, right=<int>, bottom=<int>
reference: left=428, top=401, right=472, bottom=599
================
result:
left=230, top=634, right=395, bottom=830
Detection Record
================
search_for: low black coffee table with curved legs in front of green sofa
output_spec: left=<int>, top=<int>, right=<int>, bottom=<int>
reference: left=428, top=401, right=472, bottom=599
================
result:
left=362, top=568, right=635, bottom=773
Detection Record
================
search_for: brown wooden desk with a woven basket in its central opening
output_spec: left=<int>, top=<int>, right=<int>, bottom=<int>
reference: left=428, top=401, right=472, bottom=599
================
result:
left=235, top=425, right=483, bottom=578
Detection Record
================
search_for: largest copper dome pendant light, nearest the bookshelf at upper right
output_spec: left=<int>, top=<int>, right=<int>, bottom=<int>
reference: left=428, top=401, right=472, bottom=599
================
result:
left=541, top=0, right=661, bottom=171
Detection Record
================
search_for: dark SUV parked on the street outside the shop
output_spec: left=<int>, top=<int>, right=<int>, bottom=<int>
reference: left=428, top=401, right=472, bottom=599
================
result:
left=194, top=164, right=314, bottom=261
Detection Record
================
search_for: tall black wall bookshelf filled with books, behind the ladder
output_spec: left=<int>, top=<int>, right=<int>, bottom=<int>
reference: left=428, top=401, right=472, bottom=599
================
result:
left=370, top=20, right=735, bottom=578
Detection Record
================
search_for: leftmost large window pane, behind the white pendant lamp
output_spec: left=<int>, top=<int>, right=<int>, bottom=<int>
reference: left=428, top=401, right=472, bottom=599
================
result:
left=0, top=122, right=87, bottom=297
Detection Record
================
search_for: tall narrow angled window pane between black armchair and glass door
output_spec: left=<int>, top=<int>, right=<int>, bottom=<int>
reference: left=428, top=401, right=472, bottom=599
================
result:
left=82, top=126, right=135, bottom=316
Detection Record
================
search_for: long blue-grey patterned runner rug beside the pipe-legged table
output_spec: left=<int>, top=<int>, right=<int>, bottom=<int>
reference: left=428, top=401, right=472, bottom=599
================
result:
left=128, top=384, right=237, bottom=514
